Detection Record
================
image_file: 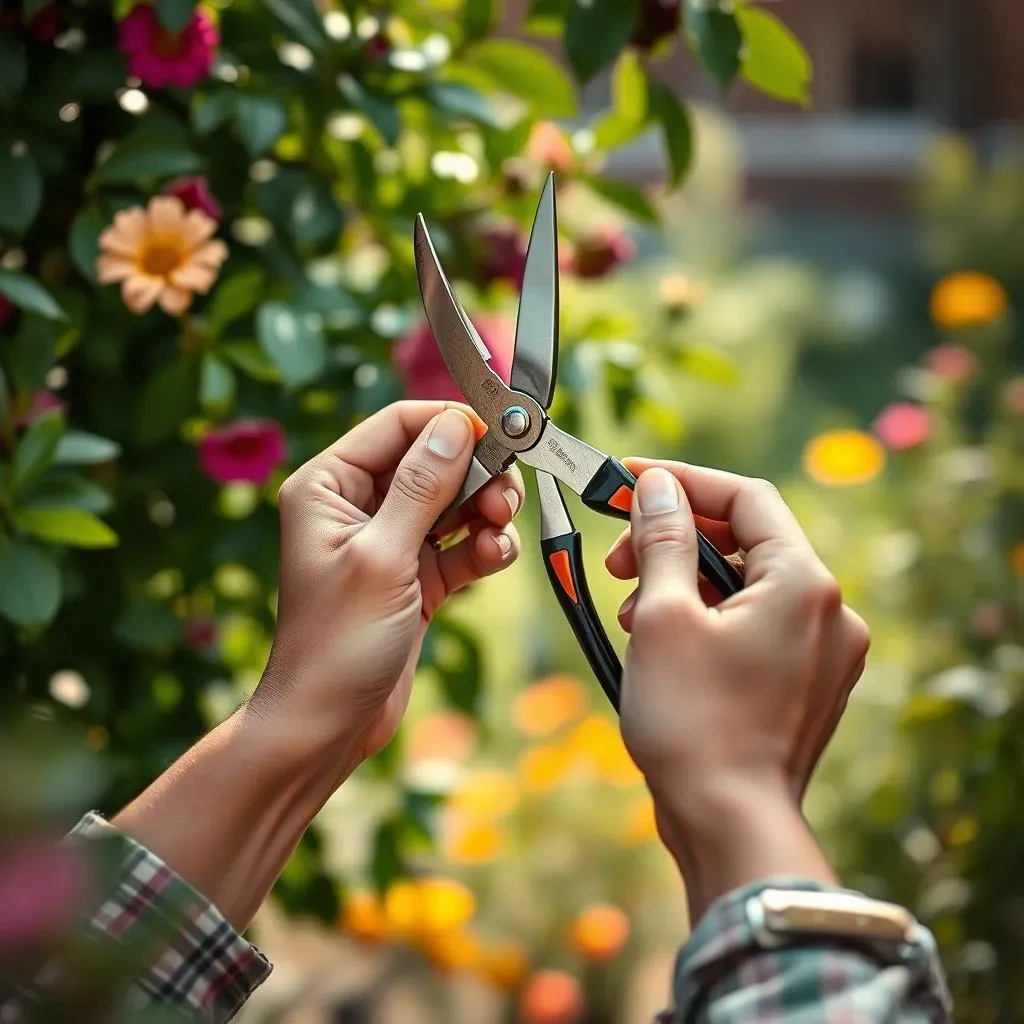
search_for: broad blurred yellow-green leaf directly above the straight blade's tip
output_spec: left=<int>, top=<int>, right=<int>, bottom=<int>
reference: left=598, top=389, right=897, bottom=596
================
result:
left=463, top=39, right=578, bottom=118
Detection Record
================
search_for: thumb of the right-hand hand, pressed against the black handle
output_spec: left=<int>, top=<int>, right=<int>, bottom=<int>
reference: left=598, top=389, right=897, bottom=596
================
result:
left=630, top=467, right=700, bottom=607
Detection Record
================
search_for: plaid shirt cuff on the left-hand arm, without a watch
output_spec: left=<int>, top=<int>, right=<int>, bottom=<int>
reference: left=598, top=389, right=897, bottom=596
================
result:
left=0, top=813, right=271, bottom=1024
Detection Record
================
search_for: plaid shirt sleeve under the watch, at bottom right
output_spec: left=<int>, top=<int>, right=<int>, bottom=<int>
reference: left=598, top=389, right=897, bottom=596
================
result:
left=655, top=879, right=952, bottom=1024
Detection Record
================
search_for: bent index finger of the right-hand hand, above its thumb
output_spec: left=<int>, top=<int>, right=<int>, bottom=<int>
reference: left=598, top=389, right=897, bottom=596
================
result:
left=624, top=458, right=814, bottom=563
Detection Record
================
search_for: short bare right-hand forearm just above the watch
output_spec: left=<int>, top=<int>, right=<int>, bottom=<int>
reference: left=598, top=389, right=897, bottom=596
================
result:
left=651, top=778, right=836, bottom=927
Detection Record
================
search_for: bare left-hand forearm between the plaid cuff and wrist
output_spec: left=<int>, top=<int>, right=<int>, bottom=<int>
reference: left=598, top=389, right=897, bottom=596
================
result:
left=113, top=709, right=354, bottom=931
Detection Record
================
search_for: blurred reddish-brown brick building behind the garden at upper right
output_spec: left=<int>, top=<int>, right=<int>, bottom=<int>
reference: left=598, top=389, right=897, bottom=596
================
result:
left=506, top=0, right=1024, bottom=212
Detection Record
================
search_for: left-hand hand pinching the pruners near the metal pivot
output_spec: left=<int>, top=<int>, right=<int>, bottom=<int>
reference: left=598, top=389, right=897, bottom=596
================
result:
left=250, top=401, right=523, bottom=770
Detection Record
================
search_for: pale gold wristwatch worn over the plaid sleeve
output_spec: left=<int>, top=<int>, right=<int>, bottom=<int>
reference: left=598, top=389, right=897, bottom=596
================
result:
left=745, top=889, right=931, bottom=952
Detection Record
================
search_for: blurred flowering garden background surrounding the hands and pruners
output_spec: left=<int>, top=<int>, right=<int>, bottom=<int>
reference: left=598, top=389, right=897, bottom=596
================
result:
left=0, top=0, right=1024, bottom=1024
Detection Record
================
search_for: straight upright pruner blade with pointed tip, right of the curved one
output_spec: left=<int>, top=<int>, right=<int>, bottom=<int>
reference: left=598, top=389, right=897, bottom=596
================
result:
left=511, top=174, right=558, bottom=409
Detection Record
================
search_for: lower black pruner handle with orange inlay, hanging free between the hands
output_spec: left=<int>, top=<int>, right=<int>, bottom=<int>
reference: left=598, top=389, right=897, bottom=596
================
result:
left=541, top=532, right=623, bottom=712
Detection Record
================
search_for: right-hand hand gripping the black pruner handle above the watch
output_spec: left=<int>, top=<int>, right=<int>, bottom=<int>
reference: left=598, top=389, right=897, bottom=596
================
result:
left=607, top=459, right=869, bottom=818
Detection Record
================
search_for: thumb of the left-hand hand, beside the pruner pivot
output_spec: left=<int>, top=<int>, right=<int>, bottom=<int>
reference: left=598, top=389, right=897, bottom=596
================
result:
left=368, top=409, right=475, bottom=557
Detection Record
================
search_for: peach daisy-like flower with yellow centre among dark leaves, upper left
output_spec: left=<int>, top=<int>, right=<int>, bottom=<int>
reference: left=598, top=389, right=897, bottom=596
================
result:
left=96, top=196, right=227, bottom=316
